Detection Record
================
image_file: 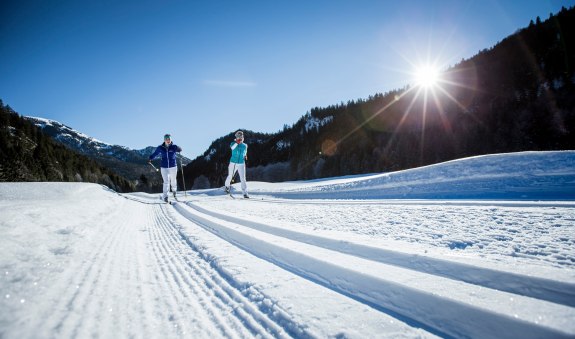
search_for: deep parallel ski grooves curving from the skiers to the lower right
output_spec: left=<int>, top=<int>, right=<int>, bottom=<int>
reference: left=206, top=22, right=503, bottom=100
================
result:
left=121, top=194, right=575, bottom=338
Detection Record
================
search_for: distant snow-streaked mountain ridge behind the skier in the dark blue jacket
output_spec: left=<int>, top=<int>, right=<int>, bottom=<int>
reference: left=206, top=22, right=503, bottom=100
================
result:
left=25, top=117, right=191, bottom=186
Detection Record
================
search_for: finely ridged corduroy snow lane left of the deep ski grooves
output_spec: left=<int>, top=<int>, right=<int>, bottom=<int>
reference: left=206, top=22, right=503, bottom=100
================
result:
left=16, top=198, right=289, bottom=338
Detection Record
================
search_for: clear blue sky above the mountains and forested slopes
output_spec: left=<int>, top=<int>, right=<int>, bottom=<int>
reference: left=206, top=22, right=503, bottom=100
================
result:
left=0, top=0, right=575, bottom=158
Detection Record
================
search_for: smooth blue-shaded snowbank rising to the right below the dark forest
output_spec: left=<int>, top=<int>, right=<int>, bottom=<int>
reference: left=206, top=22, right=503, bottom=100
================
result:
left=244, top=151, right=575, bottom=200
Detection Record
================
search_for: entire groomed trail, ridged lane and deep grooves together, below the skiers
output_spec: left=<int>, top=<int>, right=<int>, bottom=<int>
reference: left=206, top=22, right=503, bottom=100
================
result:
left=7, top=186, right=575, bottom=338
